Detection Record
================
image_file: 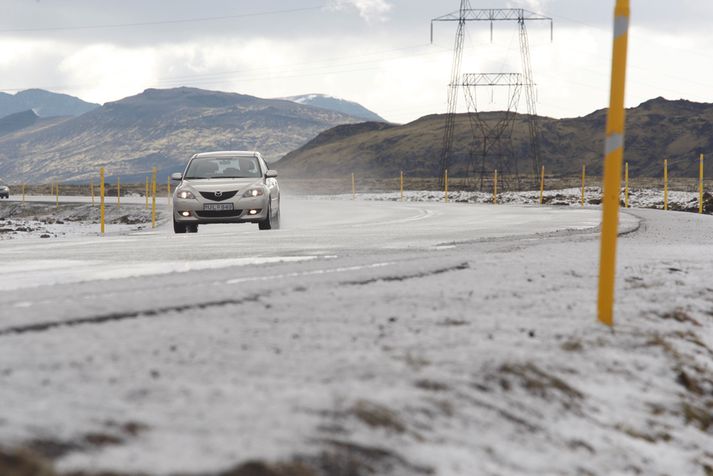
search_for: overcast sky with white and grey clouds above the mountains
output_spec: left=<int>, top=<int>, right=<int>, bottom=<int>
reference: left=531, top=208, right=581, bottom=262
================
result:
left=0, top=0, right=713, bottom=122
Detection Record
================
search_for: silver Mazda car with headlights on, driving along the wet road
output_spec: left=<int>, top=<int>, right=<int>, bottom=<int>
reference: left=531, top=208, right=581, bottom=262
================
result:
left=171, top=151, right=280, bottom=233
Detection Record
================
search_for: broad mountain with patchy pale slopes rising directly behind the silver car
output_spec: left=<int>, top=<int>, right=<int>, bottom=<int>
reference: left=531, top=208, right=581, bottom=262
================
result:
left=0, top=87, right=360, bottom=182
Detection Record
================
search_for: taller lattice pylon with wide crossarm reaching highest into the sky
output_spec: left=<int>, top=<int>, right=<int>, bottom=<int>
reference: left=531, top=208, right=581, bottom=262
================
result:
left=431, top=6, right=554, bottom=188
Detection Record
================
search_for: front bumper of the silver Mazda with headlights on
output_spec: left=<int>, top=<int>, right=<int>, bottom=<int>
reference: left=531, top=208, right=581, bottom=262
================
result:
left=173, top=197, right=268, bottom=224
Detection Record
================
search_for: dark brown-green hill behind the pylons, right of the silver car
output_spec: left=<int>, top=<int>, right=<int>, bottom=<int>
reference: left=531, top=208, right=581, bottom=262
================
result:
left=280, top=98, right=713, bottom=178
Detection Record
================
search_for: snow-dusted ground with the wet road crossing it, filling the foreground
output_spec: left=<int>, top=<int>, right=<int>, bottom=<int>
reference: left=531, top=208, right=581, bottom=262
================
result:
left=0, top=196, right=713, bottom=476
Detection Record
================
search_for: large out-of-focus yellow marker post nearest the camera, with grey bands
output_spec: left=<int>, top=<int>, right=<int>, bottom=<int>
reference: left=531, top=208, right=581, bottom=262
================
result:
left=597, top=0, right=630, bottom=327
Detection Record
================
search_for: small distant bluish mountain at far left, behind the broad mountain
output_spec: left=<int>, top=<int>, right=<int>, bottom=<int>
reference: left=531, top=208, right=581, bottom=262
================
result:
left=0, top=89, right=99, bottom=117
